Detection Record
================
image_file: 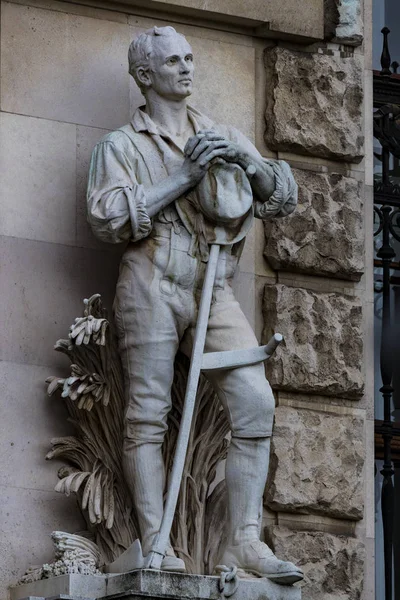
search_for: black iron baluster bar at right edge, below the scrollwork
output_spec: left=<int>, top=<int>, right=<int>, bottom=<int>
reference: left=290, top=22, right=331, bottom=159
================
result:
left=377, top=206, right=395, bottom=600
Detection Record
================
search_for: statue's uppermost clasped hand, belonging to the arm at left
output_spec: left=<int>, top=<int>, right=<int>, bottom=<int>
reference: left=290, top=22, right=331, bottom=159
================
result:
left=182, top=130, right=229, bottom=186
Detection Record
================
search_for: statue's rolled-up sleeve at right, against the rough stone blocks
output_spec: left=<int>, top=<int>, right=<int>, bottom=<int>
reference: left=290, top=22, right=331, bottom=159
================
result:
left=254, top=159, right=297, bottom=220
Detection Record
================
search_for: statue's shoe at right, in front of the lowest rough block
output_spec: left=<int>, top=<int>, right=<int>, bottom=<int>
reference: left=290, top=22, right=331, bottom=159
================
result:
left=219, top=540, right=304, bottom=584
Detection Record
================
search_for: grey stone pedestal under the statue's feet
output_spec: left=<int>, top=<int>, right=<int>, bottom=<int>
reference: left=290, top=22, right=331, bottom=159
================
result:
left=11, top=569, right=301, bottom=600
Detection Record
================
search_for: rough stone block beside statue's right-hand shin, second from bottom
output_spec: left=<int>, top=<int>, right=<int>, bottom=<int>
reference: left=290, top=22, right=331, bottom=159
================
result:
left=265, top=406, right=364, bottom=520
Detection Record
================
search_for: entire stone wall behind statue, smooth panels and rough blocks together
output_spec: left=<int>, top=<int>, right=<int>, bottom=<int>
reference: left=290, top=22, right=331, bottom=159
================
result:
left=0, top=0, right=374, bottom=600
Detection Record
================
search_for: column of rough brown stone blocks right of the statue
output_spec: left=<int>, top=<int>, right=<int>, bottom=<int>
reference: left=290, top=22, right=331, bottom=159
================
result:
left=263, top=1, right=375, bottom=600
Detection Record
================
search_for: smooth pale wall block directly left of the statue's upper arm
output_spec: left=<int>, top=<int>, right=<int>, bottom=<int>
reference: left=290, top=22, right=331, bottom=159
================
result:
left=0, top=113, right=76, bottom=244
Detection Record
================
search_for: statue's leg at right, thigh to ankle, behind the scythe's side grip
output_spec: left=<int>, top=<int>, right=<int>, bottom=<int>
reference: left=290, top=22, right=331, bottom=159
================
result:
left=184, top=286, right=275, bottom=545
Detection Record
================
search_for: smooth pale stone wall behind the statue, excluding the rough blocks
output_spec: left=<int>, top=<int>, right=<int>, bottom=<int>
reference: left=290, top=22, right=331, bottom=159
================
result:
left=0, top=0, right=269, bottom=599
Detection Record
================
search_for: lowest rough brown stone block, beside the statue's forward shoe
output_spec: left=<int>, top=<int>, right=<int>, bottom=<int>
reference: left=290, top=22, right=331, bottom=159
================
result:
left=267, top=527, right=364, bottom=600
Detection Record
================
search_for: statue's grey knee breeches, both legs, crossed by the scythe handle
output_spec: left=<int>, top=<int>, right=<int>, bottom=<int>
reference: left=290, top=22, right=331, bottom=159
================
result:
left=114, top=250, right=275, bottom=445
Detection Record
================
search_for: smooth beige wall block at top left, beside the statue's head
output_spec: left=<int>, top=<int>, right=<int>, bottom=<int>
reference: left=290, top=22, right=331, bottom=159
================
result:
left=1, top=2, right=130, bottom=129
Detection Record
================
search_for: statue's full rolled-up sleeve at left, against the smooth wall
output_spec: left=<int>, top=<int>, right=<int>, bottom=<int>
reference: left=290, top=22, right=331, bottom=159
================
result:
left=87, top=140, right=152, bottom=244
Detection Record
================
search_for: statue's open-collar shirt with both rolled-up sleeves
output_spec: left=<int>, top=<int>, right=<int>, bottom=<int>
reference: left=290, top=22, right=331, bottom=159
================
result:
left=87, top=106, right=297, bottom=243
